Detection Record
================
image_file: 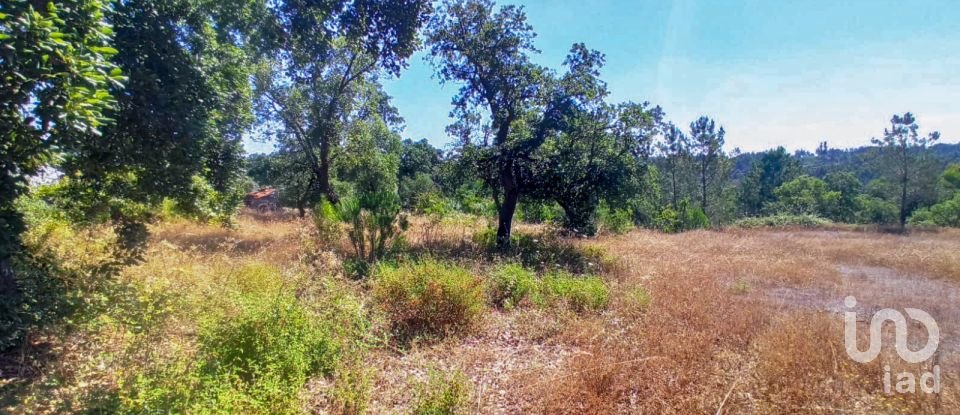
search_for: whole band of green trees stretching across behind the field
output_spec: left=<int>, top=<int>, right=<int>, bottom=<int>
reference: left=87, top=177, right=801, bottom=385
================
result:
left=0, top=0, right=960, bottom=290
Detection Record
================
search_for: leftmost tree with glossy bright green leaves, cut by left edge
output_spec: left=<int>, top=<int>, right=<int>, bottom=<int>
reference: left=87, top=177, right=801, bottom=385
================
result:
left=0, top=0, right=123, bottom=303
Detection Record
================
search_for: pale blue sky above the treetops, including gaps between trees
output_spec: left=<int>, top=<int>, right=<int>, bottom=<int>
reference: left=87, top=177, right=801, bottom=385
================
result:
left=240, top=0, right=960, bottom=152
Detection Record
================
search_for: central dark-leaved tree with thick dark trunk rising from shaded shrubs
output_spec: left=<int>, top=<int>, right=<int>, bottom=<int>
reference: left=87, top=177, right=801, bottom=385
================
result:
left=427, top=0, right=546, bottom=249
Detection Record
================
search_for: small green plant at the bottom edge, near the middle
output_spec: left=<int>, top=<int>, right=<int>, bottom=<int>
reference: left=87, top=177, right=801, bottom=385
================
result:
left=410, top=370, right=470, bottom=415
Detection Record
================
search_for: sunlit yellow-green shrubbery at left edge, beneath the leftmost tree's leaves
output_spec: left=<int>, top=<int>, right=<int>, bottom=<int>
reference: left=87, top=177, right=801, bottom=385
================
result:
left=0, top=195, right=131, bottom=350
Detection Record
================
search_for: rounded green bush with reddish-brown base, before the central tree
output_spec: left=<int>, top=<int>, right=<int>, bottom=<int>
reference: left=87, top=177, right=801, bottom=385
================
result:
left=373, top=260, right=485, bottom=340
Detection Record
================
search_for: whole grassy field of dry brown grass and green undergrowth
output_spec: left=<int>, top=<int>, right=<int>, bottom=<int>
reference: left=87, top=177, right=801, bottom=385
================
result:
left=0, top=215, right=960, bottom=414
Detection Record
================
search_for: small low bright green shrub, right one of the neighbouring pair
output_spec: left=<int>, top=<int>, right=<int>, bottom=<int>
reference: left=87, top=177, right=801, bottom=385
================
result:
left=543, top=272, right=610, bottom=311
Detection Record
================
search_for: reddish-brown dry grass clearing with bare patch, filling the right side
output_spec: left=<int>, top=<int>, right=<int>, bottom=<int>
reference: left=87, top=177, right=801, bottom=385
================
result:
left=344, top=230, right=960, bottom=414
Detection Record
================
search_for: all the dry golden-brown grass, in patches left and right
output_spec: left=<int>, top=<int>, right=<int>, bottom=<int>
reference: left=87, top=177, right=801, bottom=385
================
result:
left=7, top=213, right=960, bottom=414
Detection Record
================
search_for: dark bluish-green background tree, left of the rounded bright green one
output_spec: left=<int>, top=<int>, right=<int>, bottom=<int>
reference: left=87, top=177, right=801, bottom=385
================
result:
left=739, top=147, right=801, bottom=216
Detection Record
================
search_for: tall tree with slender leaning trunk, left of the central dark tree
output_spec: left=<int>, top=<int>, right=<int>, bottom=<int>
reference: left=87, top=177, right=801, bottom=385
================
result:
left=256, top=0, right=430, bottom=203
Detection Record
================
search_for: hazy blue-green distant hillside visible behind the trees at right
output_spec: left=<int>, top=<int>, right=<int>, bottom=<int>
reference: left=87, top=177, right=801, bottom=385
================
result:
left=732, top=143, right=960, bottom=183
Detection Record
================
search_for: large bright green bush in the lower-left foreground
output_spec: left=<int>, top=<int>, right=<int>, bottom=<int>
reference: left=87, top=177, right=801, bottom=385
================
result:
left=122, top=294, right=340, bottom=414
